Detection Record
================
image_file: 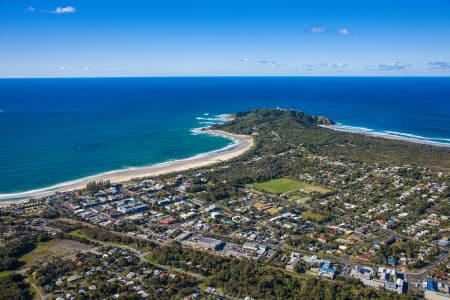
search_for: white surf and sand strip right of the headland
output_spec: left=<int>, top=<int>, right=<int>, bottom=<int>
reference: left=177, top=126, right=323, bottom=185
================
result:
left=319, top=125, right=450, bottom=148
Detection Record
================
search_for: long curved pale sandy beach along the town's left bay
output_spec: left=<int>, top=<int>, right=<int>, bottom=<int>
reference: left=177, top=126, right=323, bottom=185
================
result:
left=0, top=128, right=254, bottom=207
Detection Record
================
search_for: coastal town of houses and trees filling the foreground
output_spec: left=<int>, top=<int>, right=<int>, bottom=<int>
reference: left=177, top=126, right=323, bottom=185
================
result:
left=0, top=109, right=450, bottom=299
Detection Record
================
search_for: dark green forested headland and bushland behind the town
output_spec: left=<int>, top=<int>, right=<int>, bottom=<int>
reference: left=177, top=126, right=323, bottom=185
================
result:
left=213, top=109, right=450, bottom=171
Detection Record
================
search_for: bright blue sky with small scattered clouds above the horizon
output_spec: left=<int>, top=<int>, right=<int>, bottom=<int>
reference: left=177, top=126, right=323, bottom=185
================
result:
left=0, top=0, right=450, bottom=77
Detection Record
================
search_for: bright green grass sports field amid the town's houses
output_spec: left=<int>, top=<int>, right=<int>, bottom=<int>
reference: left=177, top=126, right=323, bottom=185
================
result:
left=253, top=178, right=331, bottom=194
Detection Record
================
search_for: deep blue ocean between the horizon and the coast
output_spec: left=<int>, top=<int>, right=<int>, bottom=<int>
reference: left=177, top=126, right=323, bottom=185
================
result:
left=0, top=77, right=450, bottom=194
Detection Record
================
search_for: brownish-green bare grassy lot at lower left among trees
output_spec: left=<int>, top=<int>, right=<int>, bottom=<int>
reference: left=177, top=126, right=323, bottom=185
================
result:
left=19, top=239, right=92, bottom=265
